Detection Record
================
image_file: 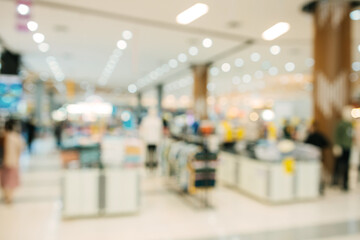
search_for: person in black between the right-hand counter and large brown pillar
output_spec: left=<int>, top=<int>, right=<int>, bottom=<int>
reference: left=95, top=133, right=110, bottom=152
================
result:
left=305, top=122, right=330, bottom=195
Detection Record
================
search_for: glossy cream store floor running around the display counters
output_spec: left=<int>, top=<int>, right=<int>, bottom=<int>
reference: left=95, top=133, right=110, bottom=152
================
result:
left=0, top=140, right=360, bottom=240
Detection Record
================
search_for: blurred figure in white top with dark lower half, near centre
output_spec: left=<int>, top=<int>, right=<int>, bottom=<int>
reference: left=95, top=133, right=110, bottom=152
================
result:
left=139, top=108, right=163, bottom=169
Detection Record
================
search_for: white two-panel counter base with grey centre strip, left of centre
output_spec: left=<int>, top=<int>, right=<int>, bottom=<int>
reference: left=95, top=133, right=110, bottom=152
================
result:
left=62, top=168, right=140, bottom=218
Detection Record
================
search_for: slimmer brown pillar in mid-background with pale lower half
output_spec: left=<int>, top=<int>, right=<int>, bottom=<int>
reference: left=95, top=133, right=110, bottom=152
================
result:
left=192, top=64, right=209, bottom=120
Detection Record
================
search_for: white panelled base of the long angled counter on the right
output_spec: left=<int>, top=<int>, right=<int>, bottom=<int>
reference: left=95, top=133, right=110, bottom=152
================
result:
left=218, top=152, right=321, bottom=203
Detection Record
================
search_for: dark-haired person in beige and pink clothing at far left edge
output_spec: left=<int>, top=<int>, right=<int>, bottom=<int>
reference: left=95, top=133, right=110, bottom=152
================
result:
left=1, top=119, right=25, bottom=204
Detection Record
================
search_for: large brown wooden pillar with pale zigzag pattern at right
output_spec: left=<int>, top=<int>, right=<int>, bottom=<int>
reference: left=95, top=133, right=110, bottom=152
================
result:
left=303, top=0, right=357, bottom=172
